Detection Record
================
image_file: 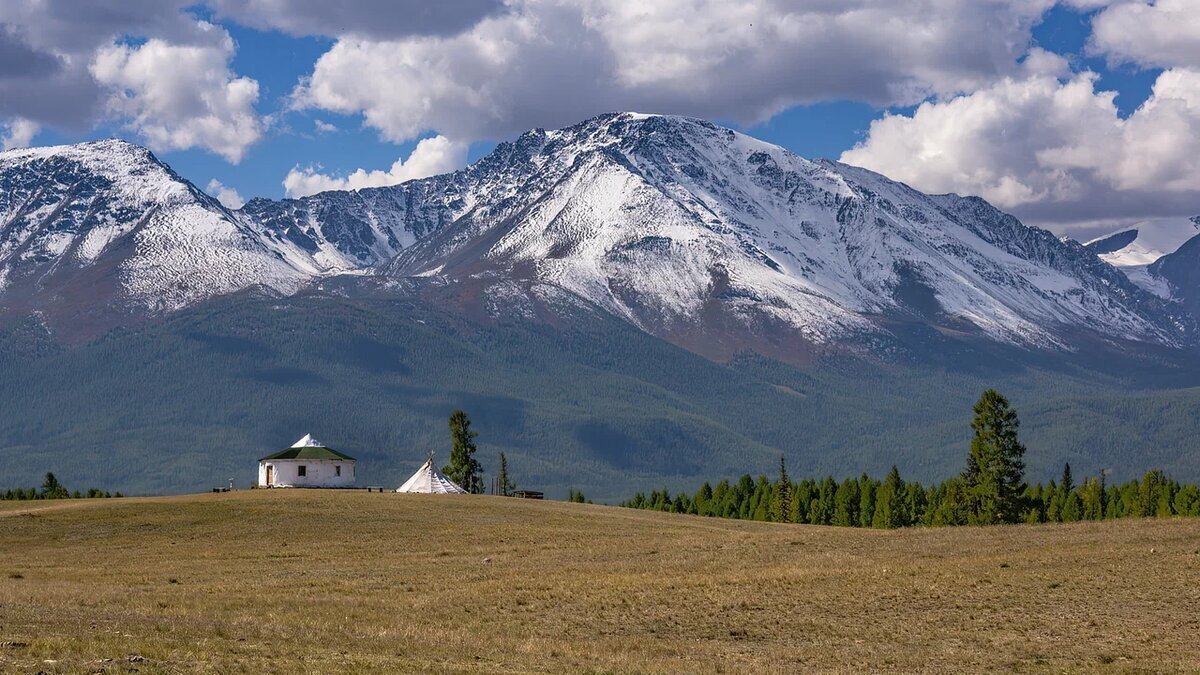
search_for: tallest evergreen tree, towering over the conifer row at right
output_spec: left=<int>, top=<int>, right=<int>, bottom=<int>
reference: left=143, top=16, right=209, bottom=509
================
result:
left=962, top=389, right=1025, bottom=525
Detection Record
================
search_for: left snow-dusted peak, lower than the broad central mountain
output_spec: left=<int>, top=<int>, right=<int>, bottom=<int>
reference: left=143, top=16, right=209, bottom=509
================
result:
left=0, top=141, right=317, bottom=311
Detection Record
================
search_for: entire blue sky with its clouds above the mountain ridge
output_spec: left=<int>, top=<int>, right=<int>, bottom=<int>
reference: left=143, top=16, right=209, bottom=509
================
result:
left=0, top=0, right=1200, bottom=232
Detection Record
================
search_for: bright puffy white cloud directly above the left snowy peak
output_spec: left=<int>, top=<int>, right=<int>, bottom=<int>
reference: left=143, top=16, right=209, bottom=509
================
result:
left=91, top=22, right=263, bottom=163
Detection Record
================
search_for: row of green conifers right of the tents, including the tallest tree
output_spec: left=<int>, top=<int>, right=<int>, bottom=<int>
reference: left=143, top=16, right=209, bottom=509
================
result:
left=622, top=389, right=1200, bottom=528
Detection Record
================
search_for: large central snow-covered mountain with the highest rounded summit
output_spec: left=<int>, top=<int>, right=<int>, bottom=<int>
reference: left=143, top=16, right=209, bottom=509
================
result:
left=386, top=113, right=1180, bottom=346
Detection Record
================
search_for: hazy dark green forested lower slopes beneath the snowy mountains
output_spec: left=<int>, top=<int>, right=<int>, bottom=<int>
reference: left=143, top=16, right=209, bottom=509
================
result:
left=0, top=295, right=1200, bottom=502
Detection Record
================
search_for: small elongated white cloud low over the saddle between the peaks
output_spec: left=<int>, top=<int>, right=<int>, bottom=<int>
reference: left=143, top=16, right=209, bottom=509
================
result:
left=283, top=136, right=469, bottom=197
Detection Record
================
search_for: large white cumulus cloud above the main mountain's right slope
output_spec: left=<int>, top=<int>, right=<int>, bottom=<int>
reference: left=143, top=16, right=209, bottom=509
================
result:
left=841, top=68, right=1200, bottom=231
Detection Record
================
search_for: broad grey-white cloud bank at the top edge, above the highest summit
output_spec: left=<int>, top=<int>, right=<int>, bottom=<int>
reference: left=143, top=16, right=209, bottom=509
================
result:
left=294, top=0, right=1052, bottom=142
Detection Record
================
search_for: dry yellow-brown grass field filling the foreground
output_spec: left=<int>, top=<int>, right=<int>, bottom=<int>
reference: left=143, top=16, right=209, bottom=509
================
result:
left=0, top=490, right=1200, bottom=673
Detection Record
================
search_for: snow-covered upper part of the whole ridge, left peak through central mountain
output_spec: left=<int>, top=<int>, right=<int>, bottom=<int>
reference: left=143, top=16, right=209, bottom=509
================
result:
left=0, top=113, right=1190, bottom=348
